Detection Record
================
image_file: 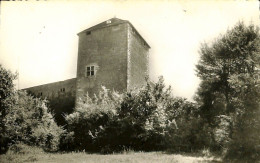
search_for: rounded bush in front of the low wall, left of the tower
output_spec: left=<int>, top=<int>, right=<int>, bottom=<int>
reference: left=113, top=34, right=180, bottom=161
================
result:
left=3, top=91, right=63, bottom=151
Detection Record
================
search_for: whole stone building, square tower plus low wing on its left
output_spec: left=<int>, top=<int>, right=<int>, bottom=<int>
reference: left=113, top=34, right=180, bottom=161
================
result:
left=25, top=18, right=150, bottom=124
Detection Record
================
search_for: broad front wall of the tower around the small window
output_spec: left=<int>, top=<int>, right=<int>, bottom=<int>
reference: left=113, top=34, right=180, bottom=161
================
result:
left=76, top=23, right=127, bottom=104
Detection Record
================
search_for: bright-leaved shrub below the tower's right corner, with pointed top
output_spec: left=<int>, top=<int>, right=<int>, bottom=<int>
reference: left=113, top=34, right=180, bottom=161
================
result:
left=118, top=77, right=171, bottom=151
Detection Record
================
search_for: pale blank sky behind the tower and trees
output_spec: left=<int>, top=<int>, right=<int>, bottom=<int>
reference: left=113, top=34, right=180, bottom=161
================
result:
left=0, top=0, right=259, bottom=100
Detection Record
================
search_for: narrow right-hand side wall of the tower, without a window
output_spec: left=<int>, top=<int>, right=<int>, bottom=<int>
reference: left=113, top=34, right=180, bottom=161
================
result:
left=128, top=25, right=149, bottom=90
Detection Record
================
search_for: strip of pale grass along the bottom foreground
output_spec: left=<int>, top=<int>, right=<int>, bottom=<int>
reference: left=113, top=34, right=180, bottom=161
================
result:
left=0, top=148, right=221, bottom=163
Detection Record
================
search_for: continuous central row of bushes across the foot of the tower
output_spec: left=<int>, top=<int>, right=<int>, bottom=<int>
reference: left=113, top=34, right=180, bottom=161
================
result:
left=63, top=77, right=196, bottom=153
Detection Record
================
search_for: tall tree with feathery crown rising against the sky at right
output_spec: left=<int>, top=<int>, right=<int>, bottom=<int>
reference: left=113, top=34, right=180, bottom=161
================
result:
left=196, top=22, right=260, bottom=122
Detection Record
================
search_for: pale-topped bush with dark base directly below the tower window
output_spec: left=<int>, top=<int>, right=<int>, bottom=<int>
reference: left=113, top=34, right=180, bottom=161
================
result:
left=63, top=87, right=121, bottom=152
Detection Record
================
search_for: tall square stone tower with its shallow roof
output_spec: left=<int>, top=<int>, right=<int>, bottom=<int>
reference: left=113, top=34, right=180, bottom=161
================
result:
left=76, top=18, right=150, bottom=104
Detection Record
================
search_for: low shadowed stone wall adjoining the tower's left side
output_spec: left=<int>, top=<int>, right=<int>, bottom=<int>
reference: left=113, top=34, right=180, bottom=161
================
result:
left=24, top=78, right=76, bottom=125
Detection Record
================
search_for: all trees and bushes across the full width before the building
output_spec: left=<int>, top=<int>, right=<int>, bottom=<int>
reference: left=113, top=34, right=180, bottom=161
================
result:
left=0, top=22, right=260, bottom=162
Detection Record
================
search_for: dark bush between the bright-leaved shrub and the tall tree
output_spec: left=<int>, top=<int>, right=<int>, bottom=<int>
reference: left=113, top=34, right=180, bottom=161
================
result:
left=165, top=98, right=203, bottom=152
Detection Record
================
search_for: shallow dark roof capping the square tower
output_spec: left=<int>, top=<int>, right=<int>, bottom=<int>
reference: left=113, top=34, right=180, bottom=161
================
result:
left=78, top=18, right=151, bottom=48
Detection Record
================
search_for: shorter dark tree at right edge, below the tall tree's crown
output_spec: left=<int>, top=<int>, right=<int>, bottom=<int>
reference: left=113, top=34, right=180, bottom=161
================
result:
left=226, top=72, right=260, bottom=162
